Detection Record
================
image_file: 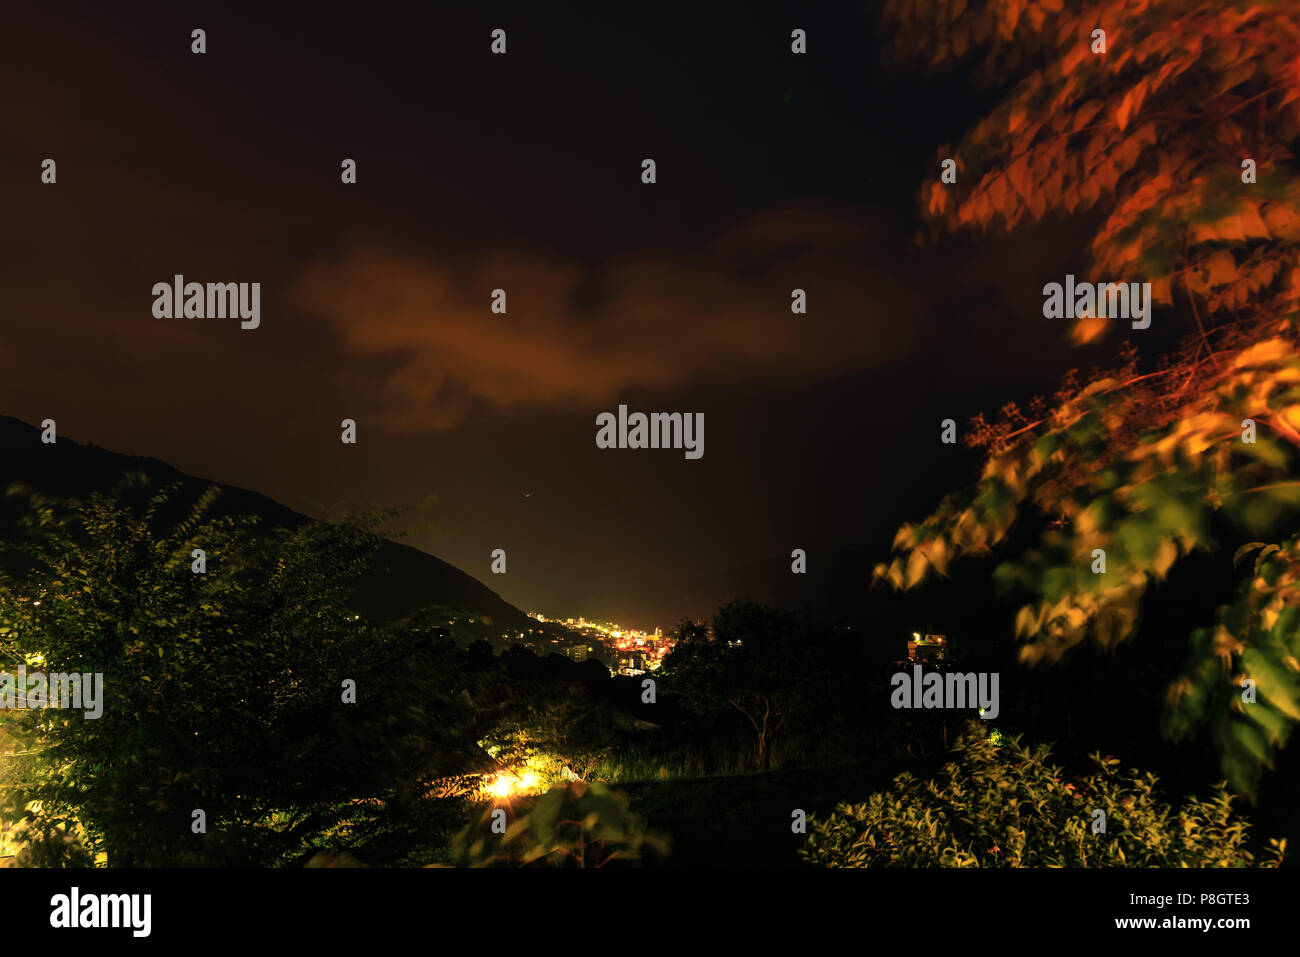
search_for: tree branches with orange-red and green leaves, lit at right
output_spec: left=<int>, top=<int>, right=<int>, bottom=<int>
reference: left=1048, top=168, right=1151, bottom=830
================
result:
left=876, top=0, right=1300, bottom=793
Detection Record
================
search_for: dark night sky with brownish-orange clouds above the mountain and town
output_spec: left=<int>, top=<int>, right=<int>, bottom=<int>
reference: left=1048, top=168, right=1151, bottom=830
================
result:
left=0, top=3, right=1114, bottom=628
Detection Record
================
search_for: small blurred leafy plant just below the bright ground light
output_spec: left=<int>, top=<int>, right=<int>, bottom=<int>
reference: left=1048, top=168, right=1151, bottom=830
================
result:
left=452, top=781, right=670, bottom=867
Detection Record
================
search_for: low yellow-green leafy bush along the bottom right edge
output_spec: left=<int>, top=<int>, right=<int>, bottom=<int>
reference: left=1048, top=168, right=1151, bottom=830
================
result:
left=800, top=723, right=1286, bottom=867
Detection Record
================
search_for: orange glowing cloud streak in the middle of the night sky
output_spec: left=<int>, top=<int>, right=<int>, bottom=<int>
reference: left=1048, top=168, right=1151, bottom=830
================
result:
left=296, top=209, right=919, bottom=432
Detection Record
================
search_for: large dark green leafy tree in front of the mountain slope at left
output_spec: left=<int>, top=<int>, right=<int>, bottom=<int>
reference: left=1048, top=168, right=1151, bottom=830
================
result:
left=0, top=477, right=462, bottom=866
